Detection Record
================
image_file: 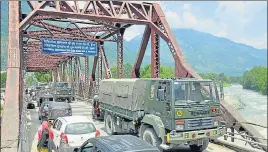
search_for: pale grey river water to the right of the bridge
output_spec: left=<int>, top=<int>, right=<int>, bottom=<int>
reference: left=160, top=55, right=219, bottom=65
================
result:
left=224, top=85, right=267, bottom=138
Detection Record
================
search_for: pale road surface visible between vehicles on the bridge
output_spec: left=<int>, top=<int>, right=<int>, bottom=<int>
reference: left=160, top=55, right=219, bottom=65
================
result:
left=27, top=101, right=234, bottom=152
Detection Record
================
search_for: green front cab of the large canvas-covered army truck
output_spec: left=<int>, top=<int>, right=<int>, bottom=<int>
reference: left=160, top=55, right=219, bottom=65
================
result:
left=147, top=79, right=224, bottom=151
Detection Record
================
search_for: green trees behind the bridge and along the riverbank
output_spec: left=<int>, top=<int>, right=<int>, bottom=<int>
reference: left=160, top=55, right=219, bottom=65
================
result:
left=1, top=64, right=267, bottom=95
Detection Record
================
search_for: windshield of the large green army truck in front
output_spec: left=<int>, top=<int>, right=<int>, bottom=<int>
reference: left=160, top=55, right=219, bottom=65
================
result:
left=174, top=81, right=219, bottom=102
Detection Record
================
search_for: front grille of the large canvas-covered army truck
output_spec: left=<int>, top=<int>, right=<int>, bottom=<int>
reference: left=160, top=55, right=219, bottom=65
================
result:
left=185, top=117, right=214, bottom=130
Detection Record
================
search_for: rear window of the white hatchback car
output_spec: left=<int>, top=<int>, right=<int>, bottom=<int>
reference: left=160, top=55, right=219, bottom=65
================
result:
left=65, top=122, right=96, bottom=135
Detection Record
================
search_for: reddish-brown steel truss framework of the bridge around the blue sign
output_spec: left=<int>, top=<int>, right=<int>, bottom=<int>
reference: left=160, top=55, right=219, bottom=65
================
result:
left=7, top=1, right=209, bottom=151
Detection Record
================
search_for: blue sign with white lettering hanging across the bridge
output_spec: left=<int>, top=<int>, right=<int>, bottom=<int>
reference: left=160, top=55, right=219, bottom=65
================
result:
left=42, top=39, right=98, bottom=56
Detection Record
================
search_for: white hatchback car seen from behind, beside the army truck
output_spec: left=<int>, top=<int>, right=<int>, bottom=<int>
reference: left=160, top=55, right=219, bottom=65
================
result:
left=52, top=116, right=100, bottom=152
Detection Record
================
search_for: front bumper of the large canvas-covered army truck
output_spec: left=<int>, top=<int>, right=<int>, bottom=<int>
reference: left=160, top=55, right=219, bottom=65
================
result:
left=162, top=127, right=226, bottom=149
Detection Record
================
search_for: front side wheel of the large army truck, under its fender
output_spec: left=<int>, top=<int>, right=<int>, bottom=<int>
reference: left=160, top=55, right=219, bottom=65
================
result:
left=142, top=128, right=161, bottom=148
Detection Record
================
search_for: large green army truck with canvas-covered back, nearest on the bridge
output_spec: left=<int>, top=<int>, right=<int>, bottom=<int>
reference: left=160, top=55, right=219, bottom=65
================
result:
left=96, top=78, right=226, bottom=151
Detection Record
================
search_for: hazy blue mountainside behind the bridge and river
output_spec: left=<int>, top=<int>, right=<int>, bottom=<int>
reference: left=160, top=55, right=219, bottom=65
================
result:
left=1, top=2, right=267, bottom=75
